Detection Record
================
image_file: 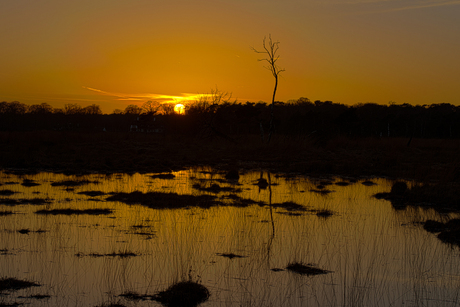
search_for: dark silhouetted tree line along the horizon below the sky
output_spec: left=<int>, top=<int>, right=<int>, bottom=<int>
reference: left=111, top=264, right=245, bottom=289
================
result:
left=0, top=96, right=460, bottom=138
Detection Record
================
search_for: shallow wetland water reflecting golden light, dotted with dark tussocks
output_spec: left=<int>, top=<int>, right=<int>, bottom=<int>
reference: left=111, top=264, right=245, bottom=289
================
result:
left=0, top=169, right=460, bottom=306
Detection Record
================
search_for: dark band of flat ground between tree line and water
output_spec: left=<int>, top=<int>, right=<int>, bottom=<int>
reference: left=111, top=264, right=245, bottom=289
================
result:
left=0, top=131, right=460, bottom=182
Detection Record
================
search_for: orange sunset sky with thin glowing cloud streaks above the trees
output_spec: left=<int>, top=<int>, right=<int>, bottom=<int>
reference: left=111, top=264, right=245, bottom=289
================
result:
left=0, top=0, right=460, bottom=113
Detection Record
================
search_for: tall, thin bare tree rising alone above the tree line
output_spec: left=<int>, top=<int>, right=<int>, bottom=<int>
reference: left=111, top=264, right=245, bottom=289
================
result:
left=252, top=35, right=284, bottom=143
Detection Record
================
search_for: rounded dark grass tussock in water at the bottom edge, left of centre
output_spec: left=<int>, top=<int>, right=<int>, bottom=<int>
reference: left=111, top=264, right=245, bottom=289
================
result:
left=152, top=281, right=210, bottom=307
